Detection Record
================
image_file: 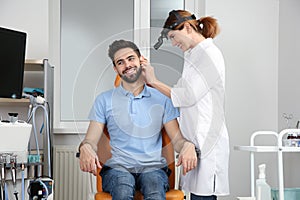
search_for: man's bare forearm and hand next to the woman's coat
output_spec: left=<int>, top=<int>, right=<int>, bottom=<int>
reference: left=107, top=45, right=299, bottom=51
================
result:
left=164, top=119, right=197, bottom=175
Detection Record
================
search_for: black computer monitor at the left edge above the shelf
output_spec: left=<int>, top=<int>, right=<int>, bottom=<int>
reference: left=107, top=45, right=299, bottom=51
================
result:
left=0, top=27, right=27, bottom=99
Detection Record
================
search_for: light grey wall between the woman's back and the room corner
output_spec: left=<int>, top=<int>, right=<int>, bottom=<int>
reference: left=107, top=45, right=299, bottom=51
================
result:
left=206, top=0, right=279, bottom=200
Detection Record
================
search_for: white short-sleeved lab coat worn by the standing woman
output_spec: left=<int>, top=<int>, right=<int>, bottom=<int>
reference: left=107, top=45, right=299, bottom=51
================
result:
left=171, top=38, right=229, bottom=196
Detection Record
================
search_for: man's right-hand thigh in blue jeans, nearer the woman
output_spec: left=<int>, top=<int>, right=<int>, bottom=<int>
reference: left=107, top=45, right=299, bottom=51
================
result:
left=137, top=169, right=169, bottom=200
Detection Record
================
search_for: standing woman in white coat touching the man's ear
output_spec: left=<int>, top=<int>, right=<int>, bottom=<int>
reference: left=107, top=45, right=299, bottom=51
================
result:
left=142, top=10, right=229, bottom=200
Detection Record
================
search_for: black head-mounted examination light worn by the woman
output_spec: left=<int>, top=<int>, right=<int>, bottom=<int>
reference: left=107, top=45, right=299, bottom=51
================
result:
left=154, top=10, right=196, bottom=50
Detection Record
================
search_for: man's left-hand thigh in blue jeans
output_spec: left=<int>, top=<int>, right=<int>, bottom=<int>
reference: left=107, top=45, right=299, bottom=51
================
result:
left=100, top=167, right=135, bottom=200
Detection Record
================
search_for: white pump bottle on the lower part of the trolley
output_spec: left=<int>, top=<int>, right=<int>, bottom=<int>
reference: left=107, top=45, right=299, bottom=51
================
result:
left=256, top=164, right=271, bottom=200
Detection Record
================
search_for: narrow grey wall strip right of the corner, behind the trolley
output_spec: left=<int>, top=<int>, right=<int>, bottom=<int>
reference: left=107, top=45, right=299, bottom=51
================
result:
left=278, top=0, right=300, bottom=187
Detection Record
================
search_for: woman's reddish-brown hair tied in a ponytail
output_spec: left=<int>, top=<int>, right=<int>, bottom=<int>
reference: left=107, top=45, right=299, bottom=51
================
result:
left=164, top=10, right=220, bottom=38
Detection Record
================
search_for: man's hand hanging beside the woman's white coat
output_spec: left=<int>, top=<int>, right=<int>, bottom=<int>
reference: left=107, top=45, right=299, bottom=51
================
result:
left=176, top=142, right=198, bottom=175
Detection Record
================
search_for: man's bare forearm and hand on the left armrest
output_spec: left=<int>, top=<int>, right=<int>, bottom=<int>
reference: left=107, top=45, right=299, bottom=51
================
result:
left=79, top=121, right=104, bottom=175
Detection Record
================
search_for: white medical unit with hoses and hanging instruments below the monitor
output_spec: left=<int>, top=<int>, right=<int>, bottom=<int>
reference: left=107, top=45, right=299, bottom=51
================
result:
left=0, top=97, right=53, bottom=200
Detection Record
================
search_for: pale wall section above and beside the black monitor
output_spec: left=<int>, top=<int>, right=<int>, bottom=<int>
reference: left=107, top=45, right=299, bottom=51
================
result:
left=0, top=0, right=49, bottom=59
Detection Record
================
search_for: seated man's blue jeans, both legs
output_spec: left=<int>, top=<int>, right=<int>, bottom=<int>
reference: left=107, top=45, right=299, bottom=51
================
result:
left=100, top=166, right=169, bottom=200
